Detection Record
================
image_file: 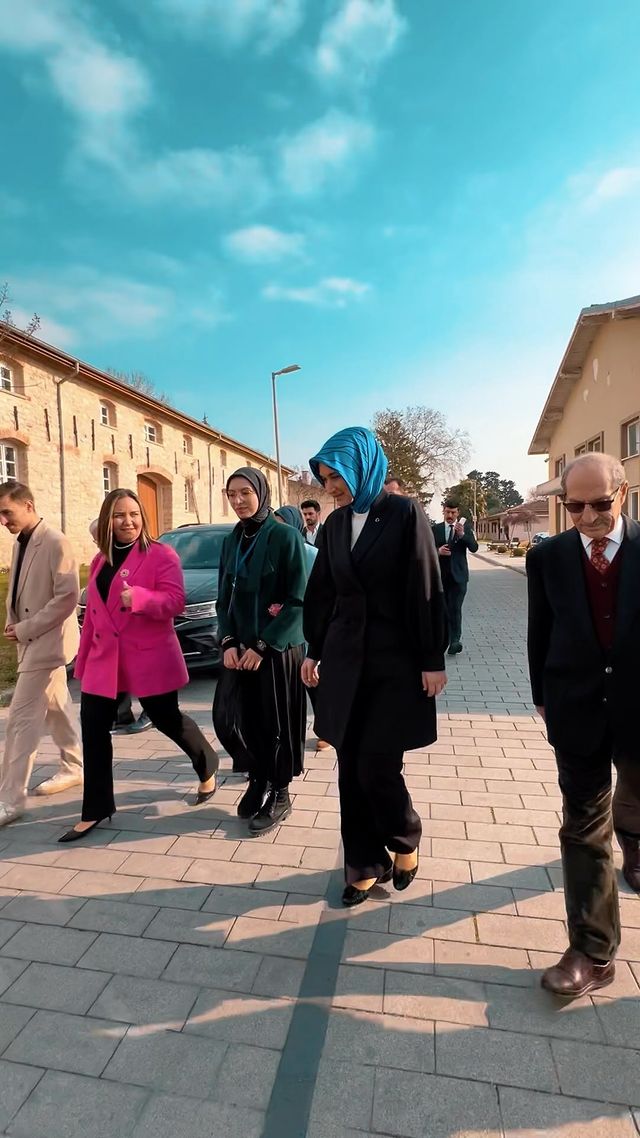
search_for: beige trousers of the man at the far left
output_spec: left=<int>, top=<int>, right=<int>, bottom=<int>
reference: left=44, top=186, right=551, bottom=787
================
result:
left=0, top=665, right=82, bottom=806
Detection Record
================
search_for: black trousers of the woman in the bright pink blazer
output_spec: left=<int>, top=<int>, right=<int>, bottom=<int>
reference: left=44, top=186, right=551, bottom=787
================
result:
left=80, top=692, right=219, bottom=822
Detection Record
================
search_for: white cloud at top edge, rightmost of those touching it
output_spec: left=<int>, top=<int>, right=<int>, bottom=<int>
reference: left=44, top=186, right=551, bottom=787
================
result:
left=313, top=0, right=407, bottom=82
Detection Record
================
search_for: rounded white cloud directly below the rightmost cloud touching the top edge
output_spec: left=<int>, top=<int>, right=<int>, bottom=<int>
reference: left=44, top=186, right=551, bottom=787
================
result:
left=279, top=109, right=376, bottom=197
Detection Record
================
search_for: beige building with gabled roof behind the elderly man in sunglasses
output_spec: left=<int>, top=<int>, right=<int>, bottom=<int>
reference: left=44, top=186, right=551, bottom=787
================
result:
left=528, top=296, right=640, bottom=534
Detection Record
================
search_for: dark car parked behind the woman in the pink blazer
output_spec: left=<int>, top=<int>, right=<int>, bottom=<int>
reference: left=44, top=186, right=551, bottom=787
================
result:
left=77, top=525, right=233, bottom=668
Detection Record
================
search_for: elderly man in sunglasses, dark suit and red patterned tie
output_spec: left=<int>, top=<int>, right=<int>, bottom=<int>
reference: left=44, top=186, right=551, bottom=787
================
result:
left=527, top=454, right=640, bottom=998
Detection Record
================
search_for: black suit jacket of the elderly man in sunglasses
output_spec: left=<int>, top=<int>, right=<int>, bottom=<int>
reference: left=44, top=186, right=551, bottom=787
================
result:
left=526, top=518, right=640, bottom=756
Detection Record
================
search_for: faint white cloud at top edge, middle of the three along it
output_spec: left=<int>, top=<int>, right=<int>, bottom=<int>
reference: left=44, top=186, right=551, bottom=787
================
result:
left=150, top=0, right=305, bottom=52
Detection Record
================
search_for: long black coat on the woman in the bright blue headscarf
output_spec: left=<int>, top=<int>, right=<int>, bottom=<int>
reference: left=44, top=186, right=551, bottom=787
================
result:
left=304, top=493, right=446, bottom=753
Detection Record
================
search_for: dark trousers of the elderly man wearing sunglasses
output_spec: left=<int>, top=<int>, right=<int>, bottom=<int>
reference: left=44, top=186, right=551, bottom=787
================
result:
left=556, top=737, right=640, bottom=960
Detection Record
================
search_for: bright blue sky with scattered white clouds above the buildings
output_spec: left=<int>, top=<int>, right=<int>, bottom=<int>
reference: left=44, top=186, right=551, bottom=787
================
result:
left=0, top=0, right=640, bottom=492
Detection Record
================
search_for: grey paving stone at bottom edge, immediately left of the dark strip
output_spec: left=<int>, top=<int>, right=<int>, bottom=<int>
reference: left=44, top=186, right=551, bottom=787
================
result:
left=133, top=1092, right=264, bottom=1138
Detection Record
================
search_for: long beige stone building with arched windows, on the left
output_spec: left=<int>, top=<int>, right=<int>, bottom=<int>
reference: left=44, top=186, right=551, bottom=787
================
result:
left=0, top=323, right=292, bottom=567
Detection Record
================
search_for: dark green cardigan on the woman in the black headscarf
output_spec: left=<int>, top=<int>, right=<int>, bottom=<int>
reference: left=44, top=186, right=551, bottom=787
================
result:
left=218, top=514, right=307, bottom=652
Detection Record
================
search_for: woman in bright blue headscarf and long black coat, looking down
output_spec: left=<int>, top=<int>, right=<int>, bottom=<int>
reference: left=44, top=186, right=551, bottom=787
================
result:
left=302, top=427, right=446, bottom=905
